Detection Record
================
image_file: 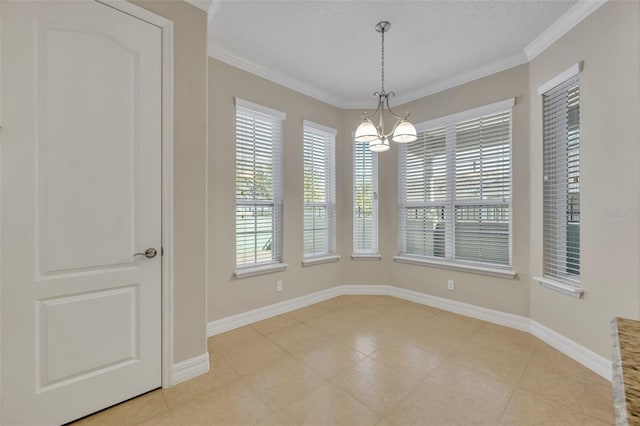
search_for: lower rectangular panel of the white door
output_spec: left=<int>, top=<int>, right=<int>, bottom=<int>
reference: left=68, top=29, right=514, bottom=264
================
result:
left=36, top=286, right=139, bottom=392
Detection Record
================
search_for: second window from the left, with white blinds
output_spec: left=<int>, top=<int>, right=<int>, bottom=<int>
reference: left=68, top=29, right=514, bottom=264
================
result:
left=303, top=120, right=336, bottom=258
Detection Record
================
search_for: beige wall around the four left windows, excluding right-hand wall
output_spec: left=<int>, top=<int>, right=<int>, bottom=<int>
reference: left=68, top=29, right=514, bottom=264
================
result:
left=208, top=58, right=529, bottom=321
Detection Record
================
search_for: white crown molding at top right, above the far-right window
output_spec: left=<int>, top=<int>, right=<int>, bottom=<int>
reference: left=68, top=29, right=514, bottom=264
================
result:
left=524, top=0, right=607, bottom=61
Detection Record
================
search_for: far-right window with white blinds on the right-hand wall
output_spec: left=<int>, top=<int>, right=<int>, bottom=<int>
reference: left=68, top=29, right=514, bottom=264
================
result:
left=542, top=75, right=580, bottom=286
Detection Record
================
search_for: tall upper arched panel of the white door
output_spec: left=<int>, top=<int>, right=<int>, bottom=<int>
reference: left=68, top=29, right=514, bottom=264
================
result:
left=36, top=21, right=139, bottom=274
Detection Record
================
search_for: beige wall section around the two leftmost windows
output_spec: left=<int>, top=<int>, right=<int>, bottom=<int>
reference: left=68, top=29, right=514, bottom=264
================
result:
left=207, top=58, right=351, bottom=321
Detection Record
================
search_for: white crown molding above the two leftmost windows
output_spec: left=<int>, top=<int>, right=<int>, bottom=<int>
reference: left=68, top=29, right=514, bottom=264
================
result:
left=208, top=43, right=345, bottom=108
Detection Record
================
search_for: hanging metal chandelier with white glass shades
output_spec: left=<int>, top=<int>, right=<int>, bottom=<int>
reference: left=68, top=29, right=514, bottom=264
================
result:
left=354, top=21, right=418, bottom=152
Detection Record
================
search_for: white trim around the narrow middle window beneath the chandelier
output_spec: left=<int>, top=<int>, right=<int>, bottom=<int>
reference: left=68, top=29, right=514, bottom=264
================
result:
left=351, top=138, right=382, bottom=255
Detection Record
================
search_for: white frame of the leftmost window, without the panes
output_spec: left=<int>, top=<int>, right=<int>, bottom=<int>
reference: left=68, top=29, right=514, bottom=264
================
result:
left=234, top=98, right=287, bottom=278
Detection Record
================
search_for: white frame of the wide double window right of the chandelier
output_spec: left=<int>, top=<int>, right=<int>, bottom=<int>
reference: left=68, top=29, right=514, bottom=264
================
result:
left=394, top=98, right=516, bottom=272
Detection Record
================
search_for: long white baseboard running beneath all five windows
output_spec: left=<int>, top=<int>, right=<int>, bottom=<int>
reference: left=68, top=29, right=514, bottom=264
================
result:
left=208, top=284, right=612, bottom=383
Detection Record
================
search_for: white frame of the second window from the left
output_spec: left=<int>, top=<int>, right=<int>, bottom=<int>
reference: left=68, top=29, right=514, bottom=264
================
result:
left=302, top=120, right=338, bottom=260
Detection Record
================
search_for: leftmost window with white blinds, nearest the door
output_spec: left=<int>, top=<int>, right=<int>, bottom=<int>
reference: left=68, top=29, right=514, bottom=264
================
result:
left=236, top=99, right=285, bottom=267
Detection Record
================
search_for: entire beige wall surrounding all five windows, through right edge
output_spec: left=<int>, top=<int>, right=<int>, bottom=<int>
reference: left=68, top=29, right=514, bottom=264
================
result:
left=208, top=1, right=640, bottom=357
